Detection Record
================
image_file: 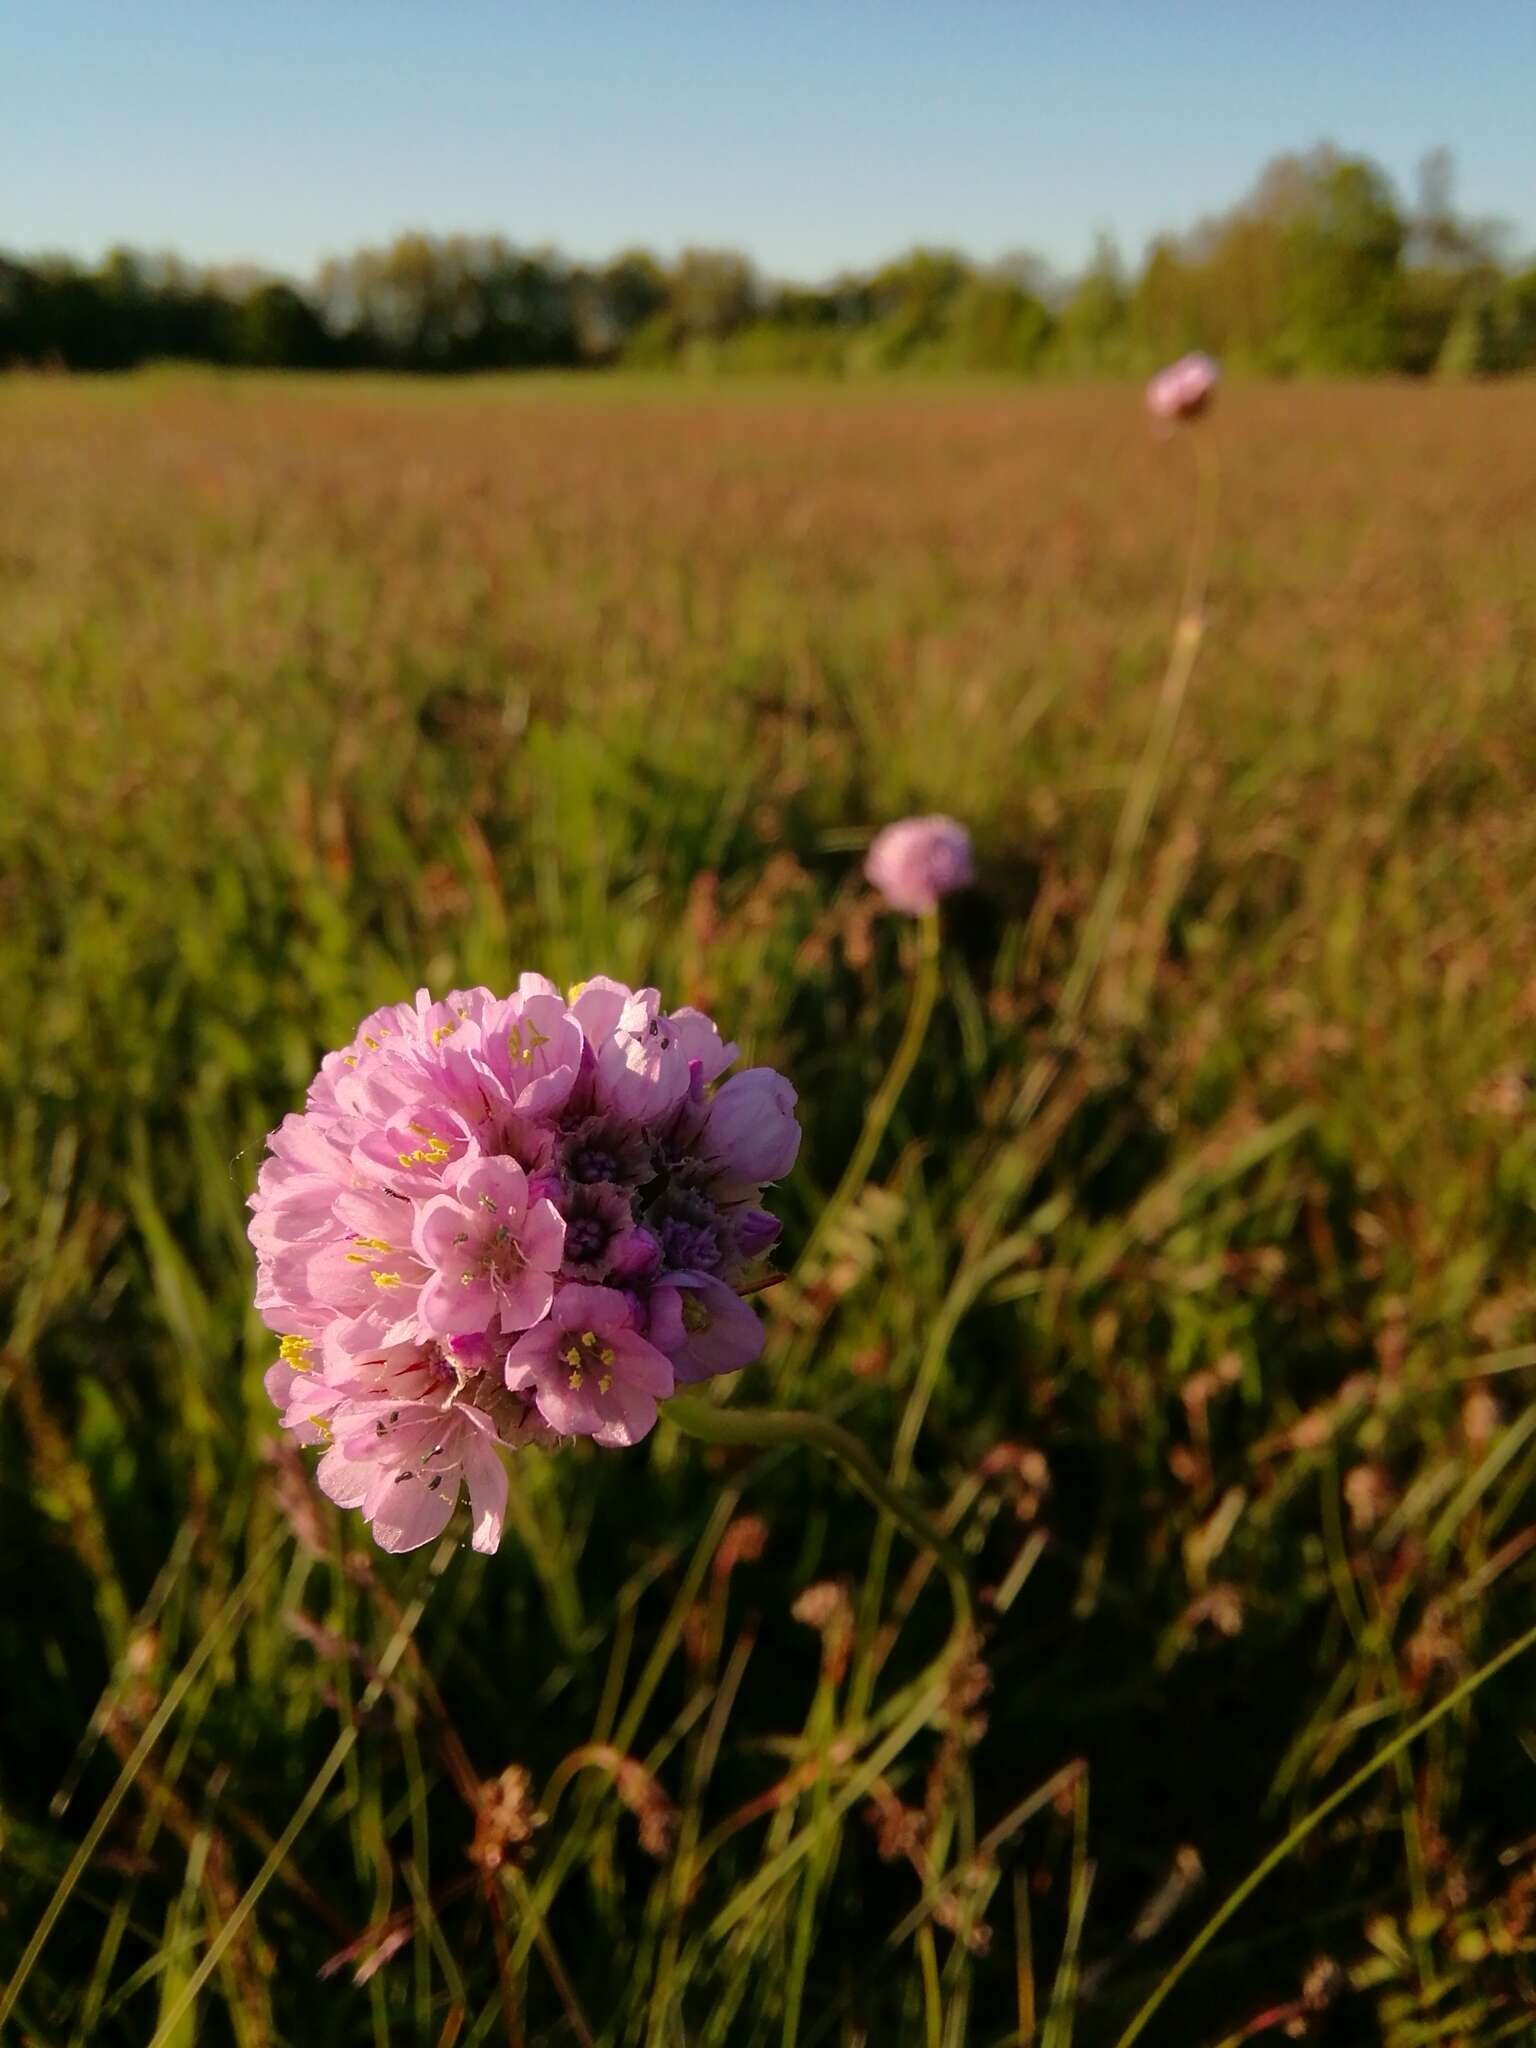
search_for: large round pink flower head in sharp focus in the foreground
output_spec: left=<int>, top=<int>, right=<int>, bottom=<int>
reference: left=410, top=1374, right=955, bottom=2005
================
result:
left=250, top=975, right=801, bottom=1550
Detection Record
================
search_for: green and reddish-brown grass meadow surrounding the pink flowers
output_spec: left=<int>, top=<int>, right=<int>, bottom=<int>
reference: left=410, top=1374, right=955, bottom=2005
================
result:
left=0, top=375, right=1536, bottom=2048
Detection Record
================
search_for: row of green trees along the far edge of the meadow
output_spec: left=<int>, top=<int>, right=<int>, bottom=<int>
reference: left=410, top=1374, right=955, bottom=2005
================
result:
left=0, top=145, right=1536, bottom=377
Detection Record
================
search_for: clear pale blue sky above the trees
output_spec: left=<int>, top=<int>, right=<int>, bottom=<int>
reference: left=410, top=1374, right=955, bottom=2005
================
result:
left=0, top=0, right=1536, bottom=279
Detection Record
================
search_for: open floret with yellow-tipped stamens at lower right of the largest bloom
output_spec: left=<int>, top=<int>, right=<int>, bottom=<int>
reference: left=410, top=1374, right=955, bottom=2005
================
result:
left=506, top=1286, right=675, bottom=1444
